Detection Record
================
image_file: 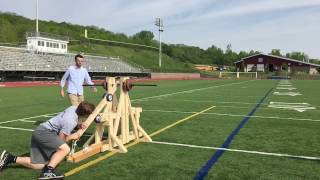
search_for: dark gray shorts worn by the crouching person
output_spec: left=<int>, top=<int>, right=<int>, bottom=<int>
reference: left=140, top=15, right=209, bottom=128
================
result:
left=30, top=126, right=65, bottom=164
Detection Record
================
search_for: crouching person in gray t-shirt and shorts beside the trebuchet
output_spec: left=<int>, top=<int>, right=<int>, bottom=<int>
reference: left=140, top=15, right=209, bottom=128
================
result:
left=0, top=101, right=95, bottom=179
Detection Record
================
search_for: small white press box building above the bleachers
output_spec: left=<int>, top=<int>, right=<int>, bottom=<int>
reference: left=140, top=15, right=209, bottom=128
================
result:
left=26, top=32, right=69, bottom=53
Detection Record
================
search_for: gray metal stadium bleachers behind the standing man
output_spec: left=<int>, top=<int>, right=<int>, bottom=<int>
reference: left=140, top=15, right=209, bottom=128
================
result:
left=0, top=47, right=142, bottom=73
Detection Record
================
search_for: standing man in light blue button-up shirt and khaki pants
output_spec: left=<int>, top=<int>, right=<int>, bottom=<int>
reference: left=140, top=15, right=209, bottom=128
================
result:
left=60, top=54, right=97, bottom=106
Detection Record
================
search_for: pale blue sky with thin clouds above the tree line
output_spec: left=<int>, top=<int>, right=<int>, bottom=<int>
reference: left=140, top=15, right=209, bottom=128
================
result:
left=0, top=0, right=320, bottom=59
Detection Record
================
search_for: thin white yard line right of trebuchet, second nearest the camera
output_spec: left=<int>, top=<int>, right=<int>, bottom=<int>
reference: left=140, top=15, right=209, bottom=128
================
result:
left=143, top=109, right=320, bottom=122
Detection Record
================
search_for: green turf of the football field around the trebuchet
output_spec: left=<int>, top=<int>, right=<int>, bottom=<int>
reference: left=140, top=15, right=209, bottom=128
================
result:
left=0, top=79, right=320, bottom=180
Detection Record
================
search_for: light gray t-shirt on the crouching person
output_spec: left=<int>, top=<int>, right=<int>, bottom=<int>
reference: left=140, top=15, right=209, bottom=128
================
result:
left=40, top=106, right=78, bottom=136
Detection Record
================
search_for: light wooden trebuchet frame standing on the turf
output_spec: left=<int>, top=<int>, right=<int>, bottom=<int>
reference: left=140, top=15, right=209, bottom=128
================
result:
left=67, top=77, right=152, bottom=163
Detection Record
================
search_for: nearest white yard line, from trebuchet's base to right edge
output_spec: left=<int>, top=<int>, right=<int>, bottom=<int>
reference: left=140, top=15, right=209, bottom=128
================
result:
left=150, top=141, right=320, bottom=160
